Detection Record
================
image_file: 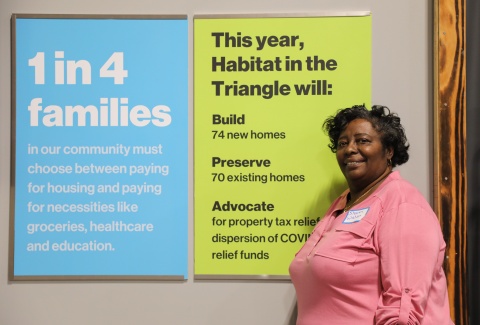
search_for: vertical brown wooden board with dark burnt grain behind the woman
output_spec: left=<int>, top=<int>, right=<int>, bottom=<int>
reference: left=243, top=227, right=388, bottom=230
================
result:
left=434, top=0, right=468, bottom=325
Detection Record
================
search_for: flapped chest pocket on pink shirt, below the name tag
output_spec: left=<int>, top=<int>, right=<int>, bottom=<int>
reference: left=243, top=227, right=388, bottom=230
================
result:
left=315, top=219, right=375, bottom=264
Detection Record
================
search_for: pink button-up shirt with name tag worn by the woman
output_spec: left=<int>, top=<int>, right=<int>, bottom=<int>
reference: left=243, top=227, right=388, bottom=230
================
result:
left=290, top=172, right=453, bottom=325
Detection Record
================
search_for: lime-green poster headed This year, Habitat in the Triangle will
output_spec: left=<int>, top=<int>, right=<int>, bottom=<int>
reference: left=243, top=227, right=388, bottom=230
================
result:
left=194, top=12, right=371, bottom=279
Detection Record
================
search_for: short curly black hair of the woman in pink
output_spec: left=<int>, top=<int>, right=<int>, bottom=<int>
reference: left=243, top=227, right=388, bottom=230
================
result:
left=323, top=105, right=410, bottom=167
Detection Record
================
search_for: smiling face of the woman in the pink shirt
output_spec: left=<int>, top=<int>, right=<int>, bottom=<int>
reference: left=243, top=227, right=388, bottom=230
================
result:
left=337, top=119, right=393, bottom=190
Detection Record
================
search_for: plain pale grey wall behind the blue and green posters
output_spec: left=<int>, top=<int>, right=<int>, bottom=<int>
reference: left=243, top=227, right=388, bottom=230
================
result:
left=0, top=0, right=433, bottom=325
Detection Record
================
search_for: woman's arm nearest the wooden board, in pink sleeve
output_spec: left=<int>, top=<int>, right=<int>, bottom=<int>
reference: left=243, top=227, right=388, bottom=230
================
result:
left=375, top=203, right=445, bottom=325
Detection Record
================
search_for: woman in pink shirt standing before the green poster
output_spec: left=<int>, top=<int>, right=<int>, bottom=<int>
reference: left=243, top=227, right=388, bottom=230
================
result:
left=290, top=106, right=453, bottom=325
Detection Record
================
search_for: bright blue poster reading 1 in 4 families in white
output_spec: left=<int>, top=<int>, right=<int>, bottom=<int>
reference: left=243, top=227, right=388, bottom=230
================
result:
left=12, top=16, right=188, bottom=279
